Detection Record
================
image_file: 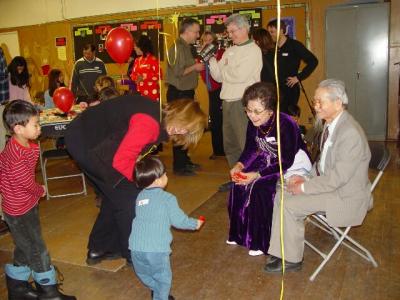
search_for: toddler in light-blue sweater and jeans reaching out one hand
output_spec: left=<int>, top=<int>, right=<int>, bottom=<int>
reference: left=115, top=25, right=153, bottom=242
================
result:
left=129, top=156, right=204, bottom=300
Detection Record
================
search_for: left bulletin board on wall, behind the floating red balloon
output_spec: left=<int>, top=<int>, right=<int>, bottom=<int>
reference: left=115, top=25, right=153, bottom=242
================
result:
left=72, top=20, right=164, bottom=63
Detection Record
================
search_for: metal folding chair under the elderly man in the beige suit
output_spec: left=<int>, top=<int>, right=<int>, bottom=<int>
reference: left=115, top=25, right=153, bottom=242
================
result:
left=304, top=143, right=390, bottom=281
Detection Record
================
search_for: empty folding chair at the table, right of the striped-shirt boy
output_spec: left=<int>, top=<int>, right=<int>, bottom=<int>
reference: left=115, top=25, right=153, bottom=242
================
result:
left=39, top=142, right=87, bottom=200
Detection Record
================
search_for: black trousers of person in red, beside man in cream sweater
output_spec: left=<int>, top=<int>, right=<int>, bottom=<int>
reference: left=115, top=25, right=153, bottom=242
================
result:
left=208, top=89, right=225, bottom=155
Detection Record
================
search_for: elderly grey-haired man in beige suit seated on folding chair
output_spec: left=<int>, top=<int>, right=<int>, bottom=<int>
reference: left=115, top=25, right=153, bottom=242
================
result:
left=264, top=79, right=373, bottom=273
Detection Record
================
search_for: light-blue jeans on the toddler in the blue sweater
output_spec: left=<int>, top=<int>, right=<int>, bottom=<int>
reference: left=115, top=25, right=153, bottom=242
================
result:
left=131, top=251, right=172, bottom=300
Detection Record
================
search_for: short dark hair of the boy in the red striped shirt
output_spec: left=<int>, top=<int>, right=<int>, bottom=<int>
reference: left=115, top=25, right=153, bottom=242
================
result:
left=3, top=100, right=39, bottom=134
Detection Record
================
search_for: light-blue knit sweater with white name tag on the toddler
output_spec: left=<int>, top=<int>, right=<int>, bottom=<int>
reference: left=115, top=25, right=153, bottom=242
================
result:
left=129, top=188, right=197, bottom=252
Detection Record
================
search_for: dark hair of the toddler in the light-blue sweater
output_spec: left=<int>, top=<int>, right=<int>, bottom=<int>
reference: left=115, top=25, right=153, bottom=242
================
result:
left=134, top=156, right=165, bottom=189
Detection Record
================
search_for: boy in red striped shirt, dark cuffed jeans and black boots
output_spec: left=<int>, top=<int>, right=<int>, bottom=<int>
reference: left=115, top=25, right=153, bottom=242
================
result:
left=0, top=100, right=76, bottom=299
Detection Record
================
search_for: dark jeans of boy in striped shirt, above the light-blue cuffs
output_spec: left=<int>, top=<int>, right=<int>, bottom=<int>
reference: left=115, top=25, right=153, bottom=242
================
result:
left=4, top=205, right=51, bottom=273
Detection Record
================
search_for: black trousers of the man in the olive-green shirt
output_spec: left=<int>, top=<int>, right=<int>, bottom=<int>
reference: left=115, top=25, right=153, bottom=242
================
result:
left=167, top=85, right=194, bottom=170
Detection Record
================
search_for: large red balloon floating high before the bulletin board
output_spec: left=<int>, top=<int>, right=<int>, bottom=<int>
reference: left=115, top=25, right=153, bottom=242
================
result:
left=106, top=27, right=134, bottom=64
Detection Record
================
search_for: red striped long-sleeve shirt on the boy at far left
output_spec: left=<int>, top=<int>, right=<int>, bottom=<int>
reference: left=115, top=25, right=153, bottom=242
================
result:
left=0, top=138, right=44, bottom=216
